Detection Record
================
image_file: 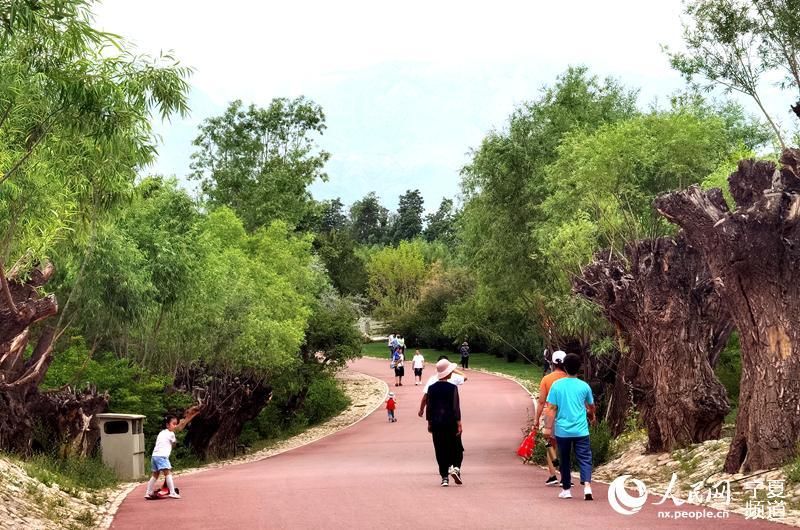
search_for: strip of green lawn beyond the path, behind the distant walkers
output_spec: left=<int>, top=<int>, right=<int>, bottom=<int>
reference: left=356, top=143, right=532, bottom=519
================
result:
left=361, top=342, right=542, bottom=391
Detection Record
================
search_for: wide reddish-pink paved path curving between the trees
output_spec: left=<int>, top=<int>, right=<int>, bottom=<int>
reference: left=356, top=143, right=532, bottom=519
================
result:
left=112, top=359, right=776, bottom=530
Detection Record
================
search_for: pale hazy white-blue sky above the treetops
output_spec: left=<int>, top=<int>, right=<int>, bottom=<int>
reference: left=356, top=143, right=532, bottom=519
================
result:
left=90, top=0, right=792, bottom=210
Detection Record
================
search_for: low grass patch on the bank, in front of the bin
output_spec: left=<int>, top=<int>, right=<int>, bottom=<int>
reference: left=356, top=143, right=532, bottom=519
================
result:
left=21, top=454, right=119, bottom=496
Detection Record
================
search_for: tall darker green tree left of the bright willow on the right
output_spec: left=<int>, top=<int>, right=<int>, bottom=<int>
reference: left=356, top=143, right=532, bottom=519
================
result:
left=456, top=68, right=636, bottom=351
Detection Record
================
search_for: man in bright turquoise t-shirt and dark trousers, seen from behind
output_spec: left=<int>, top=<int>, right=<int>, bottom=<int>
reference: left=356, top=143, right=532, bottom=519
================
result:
left=542, top=353, right=595, bottom=501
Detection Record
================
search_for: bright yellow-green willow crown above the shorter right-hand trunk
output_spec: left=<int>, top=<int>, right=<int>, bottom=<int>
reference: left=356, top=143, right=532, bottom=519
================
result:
left=535, top=97, right=770, bottom=272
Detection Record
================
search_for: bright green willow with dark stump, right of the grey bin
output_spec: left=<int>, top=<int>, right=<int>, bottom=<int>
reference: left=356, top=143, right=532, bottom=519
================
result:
left=155, top=207, right=326, bottom=457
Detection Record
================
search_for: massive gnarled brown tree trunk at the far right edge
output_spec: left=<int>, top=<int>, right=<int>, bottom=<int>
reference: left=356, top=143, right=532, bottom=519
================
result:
left=656, top=150, right=800, bottom=473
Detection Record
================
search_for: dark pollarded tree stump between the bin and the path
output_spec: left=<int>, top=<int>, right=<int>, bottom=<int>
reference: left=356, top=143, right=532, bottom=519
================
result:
left=175, top=363, right=272, bottom=458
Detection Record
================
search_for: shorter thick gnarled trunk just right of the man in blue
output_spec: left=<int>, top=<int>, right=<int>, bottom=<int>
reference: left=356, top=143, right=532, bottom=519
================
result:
left=574, top=237, right=733, bottom=451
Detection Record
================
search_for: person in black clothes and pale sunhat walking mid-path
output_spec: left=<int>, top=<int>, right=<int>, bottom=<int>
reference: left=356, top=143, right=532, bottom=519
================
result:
left=426, top=359, right=464, bottom=487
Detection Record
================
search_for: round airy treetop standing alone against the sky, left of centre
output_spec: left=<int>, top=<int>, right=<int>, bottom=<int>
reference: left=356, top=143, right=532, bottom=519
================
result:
left=191, top=97, right=330, bottom=231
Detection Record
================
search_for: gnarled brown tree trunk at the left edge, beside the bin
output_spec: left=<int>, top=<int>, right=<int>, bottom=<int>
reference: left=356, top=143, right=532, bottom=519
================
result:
left=0, top=264, right=108, bottom=455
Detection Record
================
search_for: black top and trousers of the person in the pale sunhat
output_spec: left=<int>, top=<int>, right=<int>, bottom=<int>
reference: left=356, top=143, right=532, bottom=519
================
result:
left=425, top=381, right=464, bottom=478
